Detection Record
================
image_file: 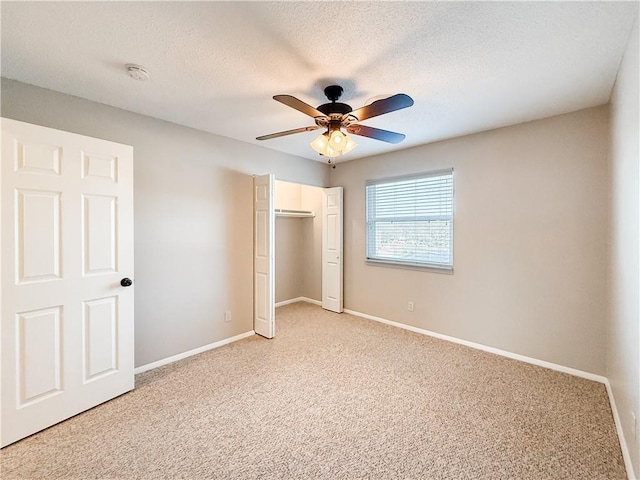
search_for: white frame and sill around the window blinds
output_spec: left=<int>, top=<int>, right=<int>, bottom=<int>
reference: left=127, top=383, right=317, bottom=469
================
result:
left=364, top=167, right=455, bottom=274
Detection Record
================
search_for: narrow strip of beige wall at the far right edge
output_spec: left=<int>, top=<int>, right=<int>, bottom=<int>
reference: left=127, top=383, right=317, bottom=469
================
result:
left=607, top=17, right=640, bottom=475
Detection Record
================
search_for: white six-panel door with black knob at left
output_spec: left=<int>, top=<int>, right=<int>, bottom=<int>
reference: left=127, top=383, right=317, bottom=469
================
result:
left=0, top=119, right=134, bottom=446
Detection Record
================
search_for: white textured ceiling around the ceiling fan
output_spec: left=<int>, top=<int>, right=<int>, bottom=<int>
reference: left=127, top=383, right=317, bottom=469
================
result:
left=0, top=1, right=638, bottom=161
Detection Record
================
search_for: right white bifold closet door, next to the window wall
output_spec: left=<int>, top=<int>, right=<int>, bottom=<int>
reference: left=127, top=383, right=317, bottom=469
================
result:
left=322, top=187, right=343, bottom=313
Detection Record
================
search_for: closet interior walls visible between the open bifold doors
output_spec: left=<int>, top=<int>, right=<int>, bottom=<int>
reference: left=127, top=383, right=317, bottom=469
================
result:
left=275, top=180, right=322, bottom=303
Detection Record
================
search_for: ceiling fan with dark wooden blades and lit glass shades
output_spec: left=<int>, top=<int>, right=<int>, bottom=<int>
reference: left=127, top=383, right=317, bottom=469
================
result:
left=256, top=85, right=413, bottom=163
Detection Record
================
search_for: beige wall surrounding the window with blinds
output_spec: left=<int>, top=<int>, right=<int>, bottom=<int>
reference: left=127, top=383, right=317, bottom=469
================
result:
left=331, top=107, right=609, bottom=374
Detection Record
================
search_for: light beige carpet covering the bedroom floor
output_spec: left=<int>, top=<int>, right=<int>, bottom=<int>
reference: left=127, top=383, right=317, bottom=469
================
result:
left=1, top=303, right=625, bottom=480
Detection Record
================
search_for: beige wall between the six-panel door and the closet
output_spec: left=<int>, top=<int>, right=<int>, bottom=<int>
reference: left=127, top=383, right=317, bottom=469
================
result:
left=2, top=79, right=328, bottom=366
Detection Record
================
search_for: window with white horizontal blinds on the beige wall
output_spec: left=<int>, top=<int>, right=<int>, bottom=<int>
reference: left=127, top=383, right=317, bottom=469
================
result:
left=366, top=169, right=453, bottom=270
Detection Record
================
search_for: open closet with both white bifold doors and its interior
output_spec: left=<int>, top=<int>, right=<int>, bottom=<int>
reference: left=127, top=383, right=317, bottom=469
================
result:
left=254, top=174, right=343, bottom=338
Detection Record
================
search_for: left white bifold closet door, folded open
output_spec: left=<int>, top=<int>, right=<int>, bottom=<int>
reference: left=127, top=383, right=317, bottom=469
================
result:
left=253, top=174, right=276, bottom=338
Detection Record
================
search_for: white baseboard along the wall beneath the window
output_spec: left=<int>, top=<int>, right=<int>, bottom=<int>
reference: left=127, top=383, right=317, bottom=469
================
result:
left=344, top=308, right=607, bottom=384
